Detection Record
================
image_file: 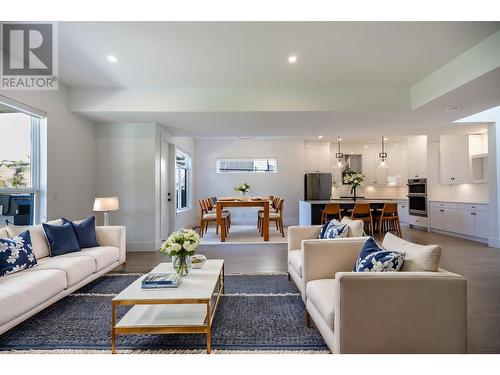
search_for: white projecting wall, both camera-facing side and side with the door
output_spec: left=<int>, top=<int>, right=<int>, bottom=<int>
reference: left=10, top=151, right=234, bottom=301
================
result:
left=96, top=123, right=196, bottom=251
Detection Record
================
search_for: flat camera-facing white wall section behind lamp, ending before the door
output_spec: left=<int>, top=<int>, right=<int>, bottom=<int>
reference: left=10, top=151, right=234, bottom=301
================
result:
left=95, top=123, right=156, bottom=251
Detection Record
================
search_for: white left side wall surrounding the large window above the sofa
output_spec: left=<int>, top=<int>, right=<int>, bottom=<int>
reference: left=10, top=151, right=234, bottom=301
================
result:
left=0, top=84, right=96, bottom=221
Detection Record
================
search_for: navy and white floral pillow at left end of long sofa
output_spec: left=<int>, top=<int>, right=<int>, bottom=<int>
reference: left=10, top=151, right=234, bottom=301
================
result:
left=0, top=230, right=37, bottom=276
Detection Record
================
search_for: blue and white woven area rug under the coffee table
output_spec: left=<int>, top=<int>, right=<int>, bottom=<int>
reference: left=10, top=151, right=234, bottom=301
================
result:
left=0, top=274, right=328, bottom=353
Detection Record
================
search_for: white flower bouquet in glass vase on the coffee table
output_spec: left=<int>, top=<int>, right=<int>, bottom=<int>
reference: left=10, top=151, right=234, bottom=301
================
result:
left=160, top=229, right=200, bottom=277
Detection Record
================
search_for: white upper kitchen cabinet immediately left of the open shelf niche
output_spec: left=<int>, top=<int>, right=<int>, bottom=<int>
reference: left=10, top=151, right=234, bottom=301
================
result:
left=439, top=135, right=471, bottom=184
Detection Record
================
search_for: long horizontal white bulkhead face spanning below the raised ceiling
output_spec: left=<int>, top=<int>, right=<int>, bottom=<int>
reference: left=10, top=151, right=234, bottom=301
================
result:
left=69, top=88, right=410, bottom=113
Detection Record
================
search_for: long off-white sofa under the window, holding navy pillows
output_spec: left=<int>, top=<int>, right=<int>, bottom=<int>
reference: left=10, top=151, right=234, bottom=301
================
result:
left=0, top=221, right=126, bottom=334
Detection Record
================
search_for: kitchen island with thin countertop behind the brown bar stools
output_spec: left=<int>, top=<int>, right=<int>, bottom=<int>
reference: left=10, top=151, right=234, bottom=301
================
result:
left=299, top=198, right=407, bottom=226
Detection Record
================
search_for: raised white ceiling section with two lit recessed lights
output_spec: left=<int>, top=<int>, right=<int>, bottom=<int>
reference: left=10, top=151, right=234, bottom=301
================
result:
left=59, top=22, right=500, bottom=88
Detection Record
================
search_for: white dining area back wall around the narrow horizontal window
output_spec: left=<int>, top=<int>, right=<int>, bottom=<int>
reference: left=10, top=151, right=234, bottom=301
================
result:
left=195, top=139, right=304, bottom=225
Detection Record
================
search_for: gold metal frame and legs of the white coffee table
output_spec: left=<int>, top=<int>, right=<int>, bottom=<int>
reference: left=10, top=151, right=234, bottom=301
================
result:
left=111, top=263, right=224, bottom=354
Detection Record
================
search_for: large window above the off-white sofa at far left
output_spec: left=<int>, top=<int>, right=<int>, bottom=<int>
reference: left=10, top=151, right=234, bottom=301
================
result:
left=0, top=102, right=40, bottom=226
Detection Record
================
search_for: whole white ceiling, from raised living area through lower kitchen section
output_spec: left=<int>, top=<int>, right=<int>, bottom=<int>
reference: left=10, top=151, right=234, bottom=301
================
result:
left=59, top=22, right=500, bottom=142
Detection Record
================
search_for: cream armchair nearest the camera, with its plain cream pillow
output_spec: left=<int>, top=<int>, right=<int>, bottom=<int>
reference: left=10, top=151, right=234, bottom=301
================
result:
left=302, top=232, right=467, bottom=353
